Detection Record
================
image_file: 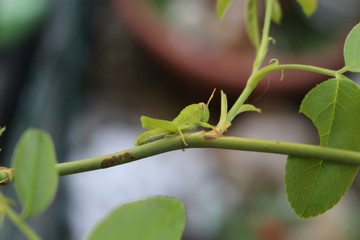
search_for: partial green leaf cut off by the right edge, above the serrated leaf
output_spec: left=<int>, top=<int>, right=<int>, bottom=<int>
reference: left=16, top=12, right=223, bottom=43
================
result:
left=344, top=23, right=360, bottom=72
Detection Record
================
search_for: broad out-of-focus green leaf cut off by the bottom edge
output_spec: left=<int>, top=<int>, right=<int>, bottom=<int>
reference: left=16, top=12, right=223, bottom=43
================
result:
left=89, top=197, right=185, bottom=240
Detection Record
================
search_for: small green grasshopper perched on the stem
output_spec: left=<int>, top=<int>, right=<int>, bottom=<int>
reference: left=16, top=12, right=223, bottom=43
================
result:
left=135, top=89, right=216, bottom=146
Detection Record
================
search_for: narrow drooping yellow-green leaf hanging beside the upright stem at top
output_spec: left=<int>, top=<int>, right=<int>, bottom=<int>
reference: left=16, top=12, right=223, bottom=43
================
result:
left=246, top=0, right=260, bottom=49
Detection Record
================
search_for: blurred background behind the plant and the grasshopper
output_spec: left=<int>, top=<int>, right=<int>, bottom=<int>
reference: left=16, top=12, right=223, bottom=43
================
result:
left=0, top=0, right=360, bottom=240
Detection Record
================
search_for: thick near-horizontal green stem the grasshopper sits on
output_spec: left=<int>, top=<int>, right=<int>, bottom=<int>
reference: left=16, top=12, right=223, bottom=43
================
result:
left=57, top=132, right=360, bottom=175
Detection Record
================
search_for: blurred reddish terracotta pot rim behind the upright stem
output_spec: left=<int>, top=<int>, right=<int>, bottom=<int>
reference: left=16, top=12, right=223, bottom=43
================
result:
left=113, top=0, right=358, bottom=95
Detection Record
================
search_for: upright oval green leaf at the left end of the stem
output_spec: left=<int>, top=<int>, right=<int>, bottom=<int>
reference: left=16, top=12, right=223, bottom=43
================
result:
left=12, top=129, right=58, bottom=217
